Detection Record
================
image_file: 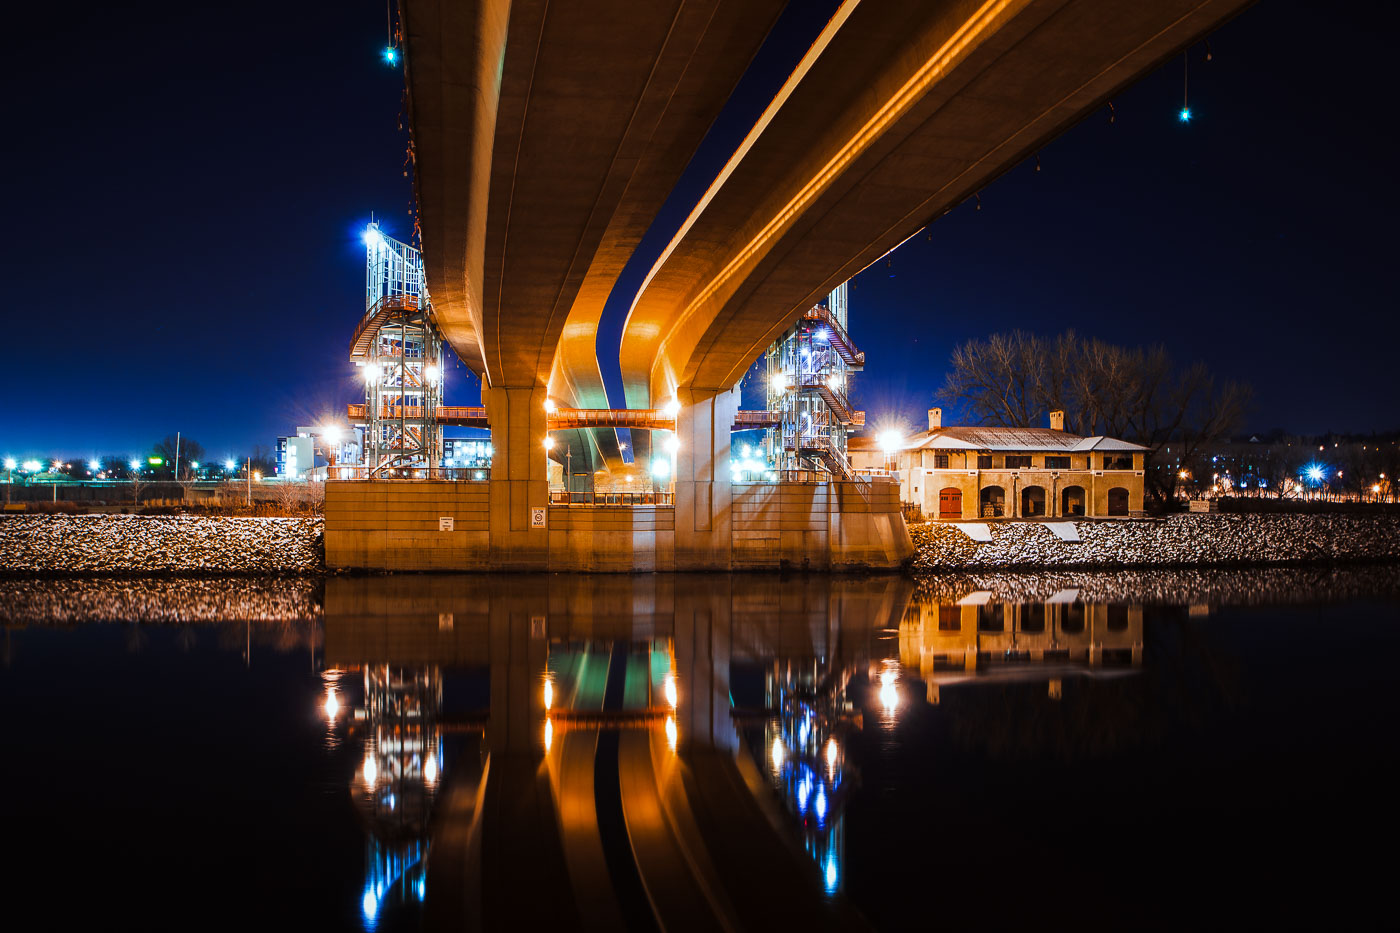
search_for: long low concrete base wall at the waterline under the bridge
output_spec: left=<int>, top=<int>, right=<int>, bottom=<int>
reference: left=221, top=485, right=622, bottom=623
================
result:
left=326, top=481, right=914, bottom=573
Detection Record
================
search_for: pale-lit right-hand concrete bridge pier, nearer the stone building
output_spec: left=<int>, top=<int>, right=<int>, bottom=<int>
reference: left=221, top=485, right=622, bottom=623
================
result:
left=675, top=388, right=739, bottom=570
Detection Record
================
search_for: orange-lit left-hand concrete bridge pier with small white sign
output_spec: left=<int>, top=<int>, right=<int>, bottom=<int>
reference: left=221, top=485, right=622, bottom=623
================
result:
left=482, top=385, right=549, bottom=570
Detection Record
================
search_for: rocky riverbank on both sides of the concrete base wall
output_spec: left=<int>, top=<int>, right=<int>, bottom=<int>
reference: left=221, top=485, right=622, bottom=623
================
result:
left=0, top=514, right=1400, bottom=576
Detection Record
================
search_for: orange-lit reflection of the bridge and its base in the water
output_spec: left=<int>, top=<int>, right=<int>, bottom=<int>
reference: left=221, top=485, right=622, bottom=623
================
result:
left=325, top=576, right=911, bottom=929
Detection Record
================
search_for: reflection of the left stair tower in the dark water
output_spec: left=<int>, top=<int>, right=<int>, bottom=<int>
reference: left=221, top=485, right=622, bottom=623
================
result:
left=357, top=664, right=442, bottom=927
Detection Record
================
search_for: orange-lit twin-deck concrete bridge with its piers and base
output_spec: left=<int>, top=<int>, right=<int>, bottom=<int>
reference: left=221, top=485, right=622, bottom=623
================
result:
left=326, top=0, right=1247, bottom=569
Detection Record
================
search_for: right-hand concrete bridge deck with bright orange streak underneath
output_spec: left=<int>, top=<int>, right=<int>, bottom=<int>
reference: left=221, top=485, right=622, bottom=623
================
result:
left=622, top=0, right=1249, bottom=406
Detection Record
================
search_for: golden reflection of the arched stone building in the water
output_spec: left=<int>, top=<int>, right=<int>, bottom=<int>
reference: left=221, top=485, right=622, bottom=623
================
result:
left=899, top=590, right=1142, bottom=702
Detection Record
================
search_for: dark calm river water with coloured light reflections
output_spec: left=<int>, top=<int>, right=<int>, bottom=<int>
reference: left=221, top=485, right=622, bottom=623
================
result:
left=0, top=566, right=1400, bottom=930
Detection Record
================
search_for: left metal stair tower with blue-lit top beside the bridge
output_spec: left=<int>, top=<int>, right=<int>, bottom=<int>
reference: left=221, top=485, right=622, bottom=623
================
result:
left=350, top=224, right=442, bottom=475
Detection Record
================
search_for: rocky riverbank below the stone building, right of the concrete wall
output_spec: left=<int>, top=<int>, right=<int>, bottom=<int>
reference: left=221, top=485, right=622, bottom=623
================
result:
left=909, top=514, right=1400, bottom=570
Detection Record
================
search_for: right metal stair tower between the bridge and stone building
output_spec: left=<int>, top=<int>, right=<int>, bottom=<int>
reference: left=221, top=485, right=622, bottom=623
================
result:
left=764, top=284, right=865, bottom=476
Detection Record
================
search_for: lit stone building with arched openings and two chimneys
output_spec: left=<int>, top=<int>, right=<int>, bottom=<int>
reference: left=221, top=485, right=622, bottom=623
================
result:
left=848, top=408, right=1148, bottom=521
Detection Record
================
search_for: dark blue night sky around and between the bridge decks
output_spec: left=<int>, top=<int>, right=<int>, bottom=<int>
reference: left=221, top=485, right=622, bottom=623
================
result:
left=0, top=0, right=1400, bottom=457
